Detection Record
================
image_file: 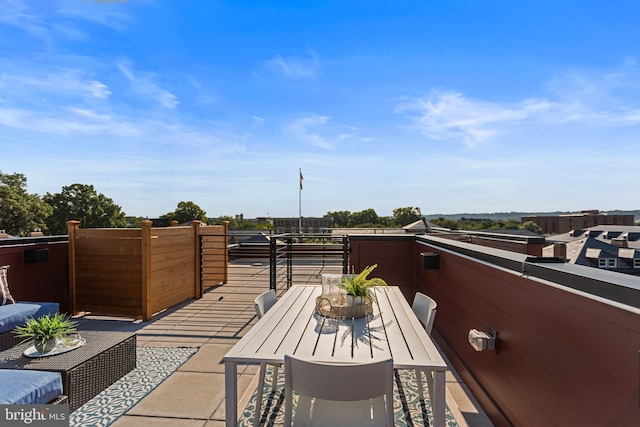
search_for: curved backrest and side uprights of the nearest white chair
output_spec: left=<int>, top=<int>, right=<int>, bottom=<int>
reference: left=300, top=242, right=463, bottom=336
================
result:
left=284, top=355, right=393, bottom=426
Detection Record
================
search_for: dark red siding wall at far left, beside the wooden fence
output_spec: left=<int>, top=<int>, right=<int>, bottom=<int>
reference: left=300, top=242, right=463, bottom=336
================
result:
left=0, top=242, right=69, bottom=313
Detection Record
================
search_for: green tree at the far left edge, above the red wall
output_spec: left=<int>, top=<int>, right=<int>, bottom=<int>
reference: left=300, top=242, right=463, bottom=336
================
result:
left=0, top=171, right=53, bottom=236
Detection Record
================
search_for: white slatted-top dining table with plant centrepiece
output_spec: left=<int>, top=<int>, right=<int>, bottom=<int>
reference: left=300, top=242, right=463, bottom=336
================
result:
left=222, top=285, right=447, bottom=427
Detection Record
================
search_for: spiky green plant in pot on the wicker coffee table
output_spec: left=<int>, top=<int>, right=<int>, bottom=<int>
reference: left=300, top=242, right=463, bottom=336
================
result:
left=13, top=313, right=77, bottom=353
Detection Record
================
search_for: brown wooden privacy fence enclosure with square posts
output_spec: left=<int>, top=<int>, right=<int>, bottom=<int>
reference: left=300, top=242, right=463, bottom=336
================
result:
left=67, top=220, right=228, bottom=321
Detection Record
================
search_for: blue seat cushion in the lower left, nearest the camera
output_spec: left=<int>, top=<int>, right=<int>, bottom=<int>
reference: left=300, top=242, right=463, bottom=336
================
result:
left=0, top=369, right=62, bottom=405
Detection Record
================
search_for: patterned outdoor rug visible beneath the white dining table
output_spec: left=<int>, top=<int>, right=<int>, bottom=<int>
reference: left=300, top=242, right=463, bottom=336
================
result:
left=239, top=366, right=458, bottom=427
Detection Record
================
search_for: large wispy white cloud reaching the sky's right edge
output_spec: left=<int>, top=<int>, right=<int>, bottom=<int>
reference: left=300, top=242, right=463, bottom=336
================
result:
left=395, top=63, right=640, bottom=147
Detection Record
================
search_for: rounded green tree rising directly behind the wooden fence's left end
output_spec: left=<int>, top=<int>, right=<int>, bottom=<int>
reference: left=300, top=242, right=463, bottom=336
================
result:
left=43, top=184, right=127, bottom=234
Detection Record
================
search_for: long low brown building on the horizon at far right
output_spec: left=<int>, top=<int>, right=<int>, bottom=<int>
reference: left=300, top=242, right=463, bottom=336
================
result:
left=521, top=210, right=634, bottom=234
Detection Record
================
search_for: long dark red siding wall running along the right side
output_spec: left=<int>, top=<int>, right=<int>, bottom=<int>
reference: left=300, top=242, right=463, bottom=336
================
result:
left=414, top=244, right=640, bottom=427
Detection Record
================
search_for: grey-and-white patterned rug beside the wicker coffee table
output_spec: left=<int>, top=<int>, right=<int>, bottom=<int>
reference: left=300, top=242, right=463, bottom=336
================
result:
left=69, top=347, right=198, bottom=427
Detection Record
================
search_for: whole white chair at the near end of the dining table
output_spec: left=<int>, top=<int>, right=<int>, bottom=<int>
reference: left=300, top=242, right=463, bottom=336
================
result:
left=284, top=356, right=394, bottom=427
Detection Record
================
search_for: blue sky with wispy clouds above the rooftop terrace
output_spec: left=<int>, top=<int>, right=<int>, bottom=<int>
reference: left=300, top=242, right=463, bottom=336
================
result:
left=0, top=0, right=640, bottom=217
